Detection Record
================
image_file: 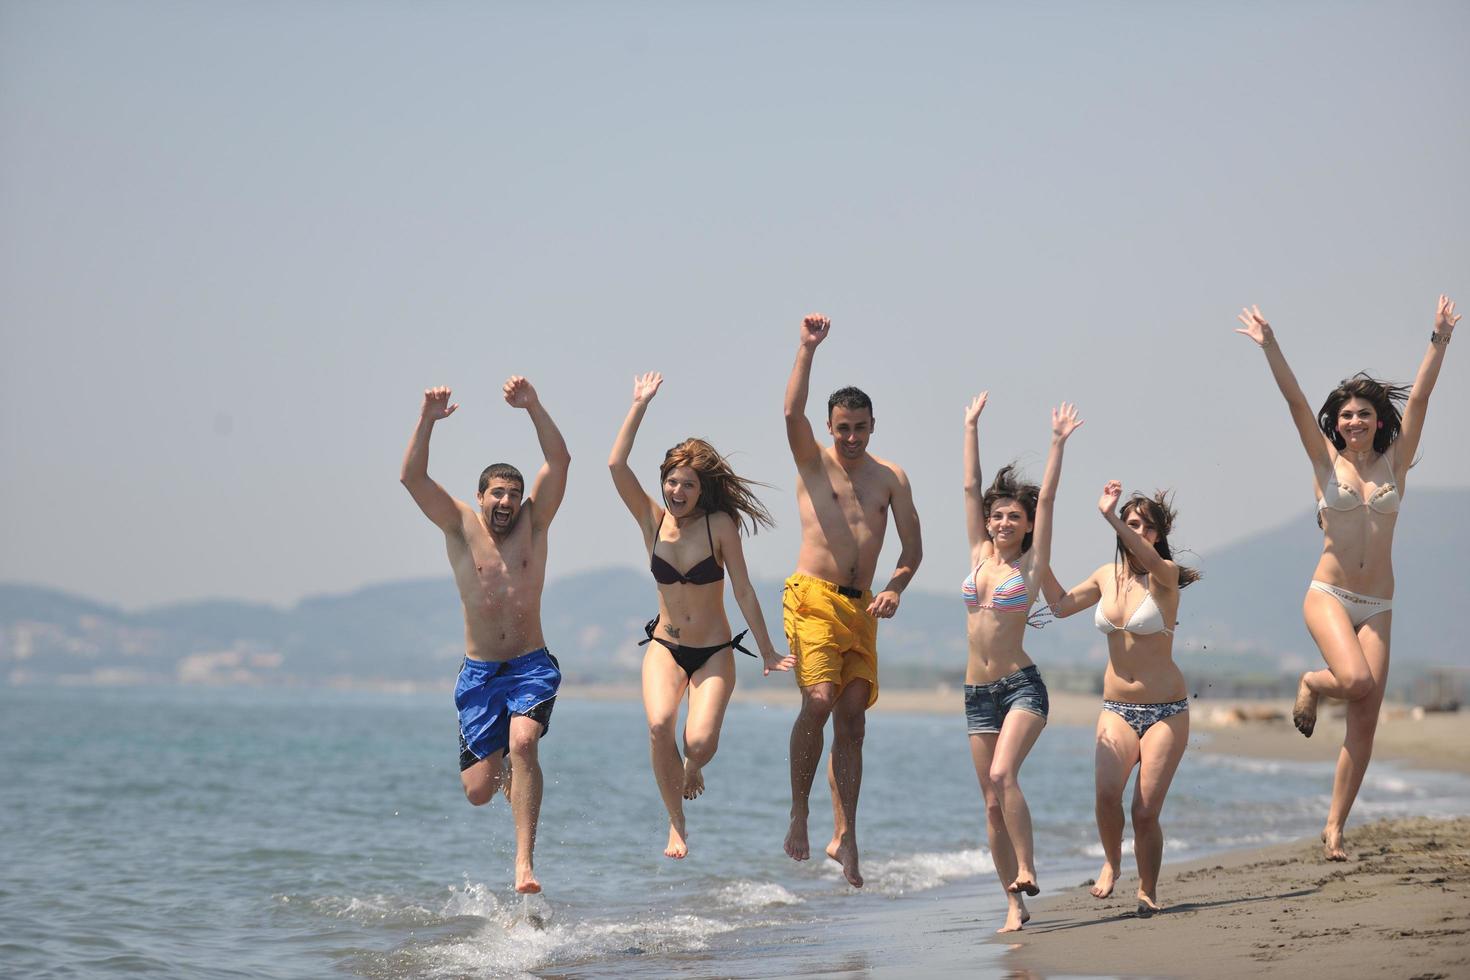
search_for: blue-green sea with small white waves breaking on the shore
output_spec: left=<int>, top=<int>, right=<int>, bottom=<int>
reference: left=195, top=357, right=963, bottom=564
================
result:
left=0, top=686, right=1470, bottom=979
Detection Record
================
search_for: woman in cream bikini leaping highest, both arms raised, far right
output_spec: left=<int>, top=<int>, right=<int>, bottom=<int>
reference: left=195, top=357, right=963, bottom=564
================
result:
left=1235, top=295, right=1460, bottom=861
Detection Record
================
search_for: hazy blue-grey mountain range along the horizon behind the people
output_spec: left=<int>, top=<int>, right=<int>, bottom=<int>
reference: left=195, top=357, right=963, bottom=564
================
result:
left=0, top=489, right=1470, bottom=686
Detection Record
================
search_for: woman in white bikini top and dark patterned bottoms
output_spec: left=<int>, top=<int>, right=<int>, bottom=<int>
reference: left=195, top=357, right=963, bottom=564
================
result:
left=1045, top=480, right=1200, bottom=917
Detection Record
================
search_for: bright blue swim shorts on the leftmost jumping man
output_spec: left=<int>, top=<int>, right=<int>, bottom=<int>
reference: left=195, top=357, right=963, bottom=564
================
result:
left=454, top=646, right=562, bottom=771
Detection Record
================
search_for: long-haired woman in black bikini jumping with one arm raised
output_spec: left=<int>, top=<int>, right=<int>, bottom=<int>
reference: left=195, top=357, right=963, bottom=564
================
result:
left=607, top=373, right=795, bottom=858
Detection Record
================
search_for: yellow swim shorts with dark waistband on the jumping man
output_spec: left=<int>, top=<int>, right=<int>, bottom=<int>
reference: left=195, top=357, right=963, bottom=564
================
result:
left=781, top=574, right=878, bottom=707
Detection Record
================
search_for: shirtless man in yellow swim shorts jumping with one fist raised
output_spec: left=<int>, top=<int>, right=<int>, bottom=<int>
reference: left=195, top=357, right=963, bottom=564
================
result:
left=782, top=313, right=923, bottom=887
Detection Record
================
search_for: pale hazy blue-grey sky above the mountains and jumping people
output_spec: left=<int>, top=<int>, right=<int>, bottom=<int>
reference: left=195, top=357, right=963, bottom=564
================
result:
left=0, top=1, right=1470, bottom=607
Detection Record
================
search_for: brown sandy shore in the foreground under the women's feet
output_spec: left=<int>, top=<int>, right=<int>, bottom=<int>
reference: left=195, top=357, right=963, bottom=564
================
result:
left=995, top=818, right=1470, bottom=979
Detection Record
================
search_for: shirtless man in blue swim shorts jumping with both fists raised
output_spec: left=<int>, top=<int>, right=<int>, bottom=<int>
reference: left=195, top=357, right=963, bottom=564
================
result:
left=401, top=376, right=572, bottom=893
